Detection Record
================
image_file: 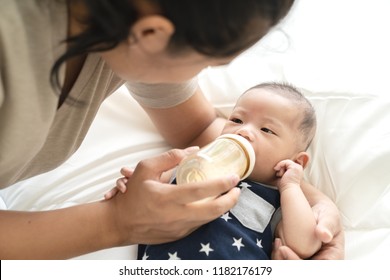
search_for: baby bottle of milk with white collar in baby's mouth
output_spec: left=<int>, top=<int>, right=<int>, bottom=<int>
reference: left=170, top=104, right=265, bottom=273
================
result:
left=176, top=134, right=255, bottom=184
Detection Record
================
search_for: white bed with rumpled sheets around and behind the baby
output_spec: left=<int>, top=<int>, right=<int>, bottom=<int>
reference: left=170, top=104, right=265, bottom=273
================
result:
left=0, top=0, right=390, bottom=260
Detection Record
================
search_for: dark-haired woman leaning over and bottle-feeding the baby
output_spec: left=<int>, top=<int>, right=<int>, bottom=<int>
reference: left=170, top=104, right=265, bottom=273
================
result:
left=0, top=0, right=340, bottom=259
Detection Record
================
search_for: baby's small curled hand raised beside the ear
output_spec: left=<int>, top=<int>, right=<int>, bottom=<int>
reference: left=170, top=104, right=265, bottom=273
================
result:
left=274, top=159, right=303, bottom=188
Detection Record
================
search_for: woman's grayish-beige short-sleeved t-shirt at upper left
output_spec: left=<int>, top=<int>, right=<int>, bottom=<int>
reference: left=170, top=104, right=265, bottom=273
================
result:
left=0, top=0, right=195, bottom=188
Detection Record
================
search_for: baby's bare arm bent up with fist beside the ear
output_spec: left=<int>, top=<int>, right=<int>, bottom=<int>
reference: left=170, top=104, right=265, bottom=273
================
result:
left=275, top=160, right=321, bottom=259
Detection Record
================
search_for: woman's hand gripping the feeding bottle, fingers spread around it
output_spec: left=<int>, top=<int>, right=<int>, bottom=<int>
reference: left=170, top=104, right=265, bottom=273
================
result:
left=105, top=149, right=240, bottom=245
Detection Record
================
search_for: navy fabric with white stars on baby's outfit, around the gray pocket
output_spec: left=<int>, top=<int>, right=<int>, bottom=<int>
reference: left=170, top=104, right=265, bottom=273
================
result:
left=138, top=180, right=280, bottom=260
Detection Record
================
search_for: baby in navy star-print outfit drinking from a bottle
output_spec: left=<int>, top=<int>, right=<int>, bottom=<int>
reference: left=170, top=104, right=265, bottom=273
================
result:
left=109, top=83, right=321, bottom=259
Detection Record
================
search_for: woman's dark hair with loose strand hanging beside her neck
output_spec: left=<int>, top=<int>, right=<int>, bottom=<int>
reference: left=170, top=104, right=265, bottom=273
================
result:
left=51, top=0, right=294, bottom=96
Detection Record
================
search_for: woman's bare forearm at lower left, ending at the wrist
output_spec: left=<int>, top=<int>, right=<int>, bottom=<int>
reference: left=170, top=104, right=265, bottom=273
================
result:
left=0, top=202, right=118, bottom=259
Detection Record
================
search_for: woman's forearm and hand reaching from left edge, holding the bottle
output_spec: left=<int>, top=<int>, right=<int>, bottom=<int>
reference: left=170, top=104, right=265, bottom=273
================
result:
left=0, top=150, right=239, bottom=259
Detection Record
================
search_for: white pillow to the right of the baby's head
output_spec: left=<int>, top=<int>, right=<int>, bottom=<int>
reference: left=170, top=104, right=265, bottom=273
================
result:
left=306, top=93, right=390, bottom=228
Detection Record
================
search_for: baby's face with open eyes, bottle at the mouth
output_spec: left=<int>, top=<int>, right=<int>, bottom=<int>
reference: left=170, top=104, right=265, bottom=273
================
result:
left=222, top=89, right=302, bottom=184
